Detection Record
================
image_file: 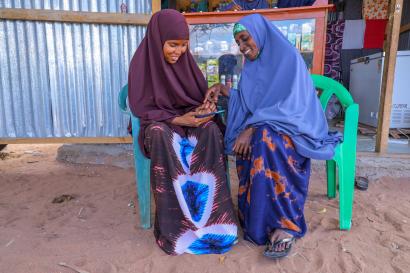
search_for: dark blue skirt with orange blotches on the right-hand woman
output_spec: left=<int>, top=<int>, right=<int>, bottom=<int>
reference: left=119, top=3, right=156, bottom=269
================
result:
left=236, top=125, right=310, bottom=245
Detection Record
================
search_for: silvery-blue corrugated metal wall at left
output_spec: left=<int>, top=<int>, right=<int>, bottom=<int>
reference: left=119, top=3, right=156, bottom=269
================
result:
left=0, top=0, right=151, bottom=138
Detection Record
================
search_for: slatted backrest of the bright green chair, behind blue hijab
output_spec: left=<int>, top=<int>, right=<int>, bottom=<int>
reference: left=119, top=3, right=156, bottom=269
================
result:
left=312, top=74, right=354, bottom=110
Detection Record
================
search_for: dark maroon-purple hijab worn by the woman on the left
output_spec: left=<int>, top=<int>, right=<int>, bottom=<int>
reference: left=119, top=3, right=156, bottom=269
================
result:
left=128, top=9, right=207, bottom=155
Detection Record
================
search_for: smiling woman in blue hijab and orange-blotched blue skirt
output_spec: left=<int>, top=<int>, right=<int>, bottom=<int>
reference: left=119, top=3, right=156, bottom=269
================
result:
left=206, top=14, right=341, bottom=258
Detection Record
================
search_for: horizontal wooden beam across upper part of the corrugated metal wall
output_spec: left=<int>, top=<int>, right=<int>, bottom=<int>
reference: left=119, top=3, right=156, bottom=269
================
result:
left=0, top=9, right=151, bottom=25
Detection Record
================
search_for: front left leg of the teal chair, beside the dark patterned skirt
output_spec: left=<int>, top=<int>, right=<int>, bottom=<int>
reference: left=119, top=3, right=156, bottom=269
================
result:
left=132, top=119, right=151, bottom=229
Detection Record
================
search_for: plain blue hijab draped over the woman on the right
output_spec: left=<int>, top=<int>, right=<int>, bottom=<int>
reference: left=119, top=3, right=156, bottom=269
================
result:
left=225, top=14, right=341, bottom=159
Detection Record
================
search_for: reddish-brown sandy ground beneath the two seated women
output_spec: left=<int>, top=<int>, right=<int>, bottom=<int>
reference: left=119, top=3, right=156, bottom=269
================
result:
left=0, top=142, right=410, bottom=273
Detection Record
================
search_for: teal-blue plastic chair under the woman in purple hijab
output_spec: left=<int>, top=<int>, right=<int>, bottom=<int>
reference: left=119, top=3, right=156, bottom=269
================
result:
left=118, top=85, right=230, bottom=229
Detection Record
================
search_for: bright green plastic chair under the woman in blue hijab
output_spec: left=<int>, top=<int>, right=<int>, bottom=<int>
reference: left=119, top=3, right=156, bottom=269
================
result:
left=312, top=75, right=359, bottom=230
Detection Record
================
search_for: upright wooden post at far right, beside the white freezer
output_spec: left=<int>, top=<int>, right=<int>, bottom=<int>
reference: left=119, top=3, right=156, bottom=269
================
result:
left=376, top=0, right=403, bottom=153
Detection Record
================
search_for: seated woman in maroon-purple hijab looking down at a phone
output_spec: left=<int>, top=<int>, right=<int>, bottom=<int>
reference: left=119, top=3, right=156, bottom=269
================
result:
left=128, top=10, right=237, bottom=255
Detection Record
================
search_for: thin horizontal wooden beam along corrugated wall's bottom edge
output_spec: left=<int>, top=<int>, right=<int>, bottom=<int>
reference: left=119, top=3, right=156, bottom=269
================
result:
left=0, top=137, right=132, bottom=144
